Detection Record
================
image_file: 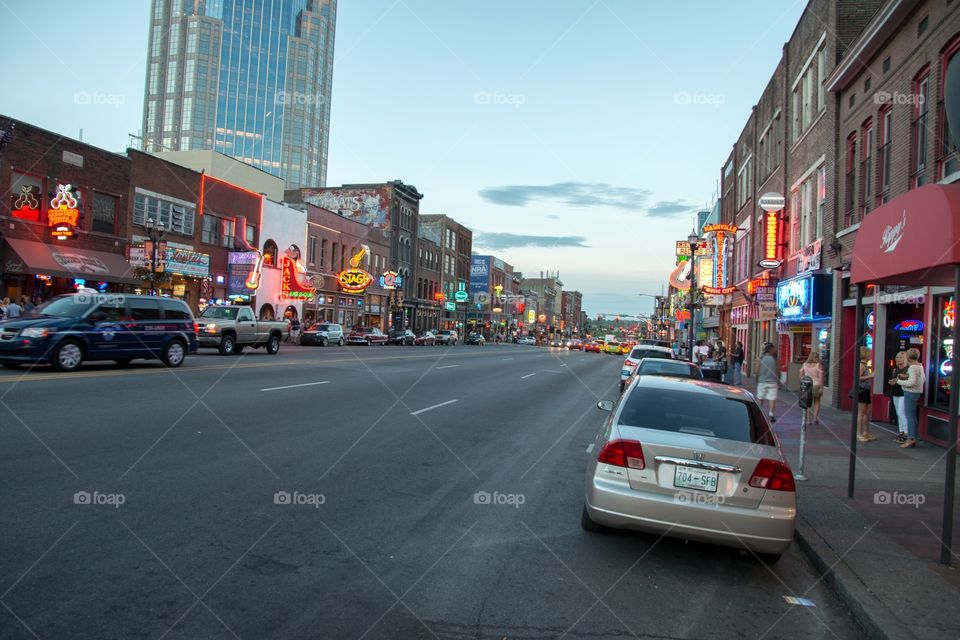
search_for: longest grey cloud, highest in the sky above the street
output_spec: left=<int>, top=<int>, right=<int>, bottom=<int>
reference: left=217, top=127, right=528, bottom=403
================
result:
left=478, top=182, right=650, bottom=211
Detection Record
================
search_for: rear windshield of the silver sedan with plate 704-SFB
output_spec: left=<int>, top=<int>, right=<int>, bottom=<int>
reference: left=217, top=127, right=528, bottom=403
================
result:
left=620, top=387, right=775, bottom=446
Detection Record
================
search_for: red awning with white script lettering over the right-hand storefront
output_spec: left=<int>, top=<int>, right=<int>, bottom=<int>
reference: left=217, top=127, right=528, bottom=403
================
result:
left=850, top=184, right=960, bottom=286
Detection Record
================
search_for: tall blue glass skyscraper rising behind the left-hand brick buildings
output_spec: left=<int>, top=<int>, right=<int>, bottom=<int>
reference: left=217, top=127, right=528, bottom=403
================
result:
left=142, top=0, right=337, bottom=189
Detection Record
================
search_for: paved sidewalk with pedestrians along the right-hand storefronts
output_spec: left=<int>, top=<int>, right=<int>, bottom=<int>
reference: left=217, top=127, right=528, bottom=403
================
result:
left=744, top=378, right=960, bottom=640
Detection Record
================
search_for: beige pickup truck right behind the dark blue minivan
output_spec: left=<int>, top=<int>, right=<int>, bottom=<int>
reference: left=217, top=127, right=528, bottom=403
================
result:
left=197, top=306, right=290, bottom=356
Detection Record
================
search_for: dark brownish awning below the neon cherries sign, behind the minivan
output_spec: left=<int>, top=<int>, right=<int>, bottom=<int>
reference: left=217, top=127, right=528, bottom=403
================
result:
left=2, top=238, right=143, bottom=284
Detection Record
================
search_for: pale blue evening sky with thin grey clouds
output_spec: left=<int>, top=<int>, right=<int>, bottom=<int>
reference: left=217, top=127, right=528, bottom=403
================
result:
left=0, top=0, right=805, bottom=316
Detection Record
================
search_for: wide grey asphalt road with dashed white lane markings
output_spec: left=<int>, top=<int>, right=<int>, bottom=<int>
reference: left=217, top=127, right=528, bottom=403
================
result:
left=0, top=345, right=861, bottom=639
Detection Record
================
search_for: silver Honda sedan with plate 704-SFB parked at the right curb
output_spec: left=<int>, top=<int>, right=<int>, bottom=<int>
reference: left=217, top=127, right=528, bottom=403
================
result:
left=580, top=376, right=797, bottom=563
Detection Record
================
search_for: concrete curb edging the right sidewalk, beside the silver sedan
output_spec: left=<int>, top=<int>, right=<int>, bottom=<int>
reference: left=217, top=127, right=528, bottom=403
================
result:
left=794, top=515, right=917, bottom=640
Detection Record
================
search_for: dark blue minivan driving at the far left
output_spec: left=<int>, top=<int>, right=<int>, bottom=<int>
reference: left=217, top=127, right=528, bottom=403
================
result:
left=0, top=291, right=197, bottom=371
